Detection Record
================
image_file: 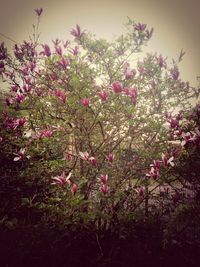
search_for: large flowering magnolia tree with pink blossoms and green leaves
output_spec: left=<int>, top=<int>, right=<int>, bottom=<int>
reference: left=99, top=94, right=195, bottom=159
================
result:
left=0, top=9, right=200, bottom=234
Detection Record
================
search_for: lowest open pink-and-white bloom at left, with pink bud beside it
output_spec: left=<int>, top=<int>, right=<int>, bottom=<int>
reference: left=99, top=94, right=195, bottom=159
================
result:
left=51, top=172, right=78, bottom=195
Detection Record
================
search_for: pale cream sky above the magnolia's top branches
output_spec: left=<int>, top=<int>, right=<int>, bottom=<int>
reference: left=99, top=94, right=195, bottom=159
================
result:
left=0, top=0, right=200, bottom=85
